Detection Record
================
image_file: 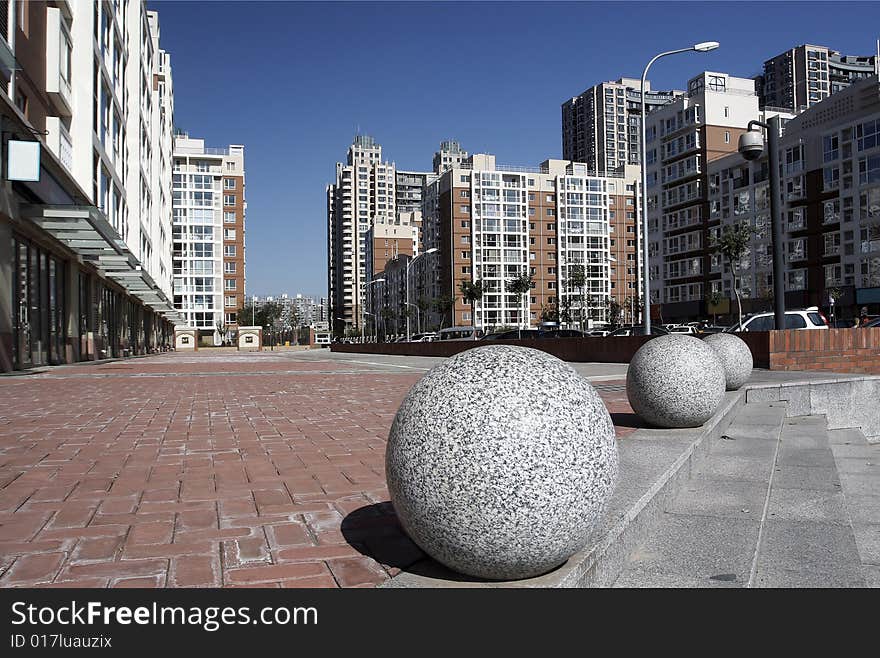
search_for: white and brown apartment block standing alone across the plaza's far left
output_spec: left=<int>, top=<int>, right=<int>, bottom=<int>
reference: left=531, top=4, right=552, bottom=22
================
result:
left=172, top=133, right=247, bottom=342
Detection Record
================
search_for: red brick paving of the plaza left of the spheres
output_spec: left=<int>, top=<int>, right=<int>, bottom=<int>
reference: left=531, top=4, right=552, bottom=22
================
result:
left=0, top=352, right=637, bottom=587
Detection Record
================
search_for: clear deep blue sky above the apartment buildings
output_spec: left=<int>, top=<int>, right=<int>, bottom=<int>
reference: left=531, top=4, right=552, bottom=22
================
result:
left=148, top=1, right=880, bottom=295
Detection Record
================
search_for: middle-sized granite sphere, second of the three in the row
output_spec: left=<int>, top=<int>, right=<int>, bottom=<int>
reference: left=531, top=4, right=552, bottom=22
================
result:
left=626, top=335, right=726, bottom=427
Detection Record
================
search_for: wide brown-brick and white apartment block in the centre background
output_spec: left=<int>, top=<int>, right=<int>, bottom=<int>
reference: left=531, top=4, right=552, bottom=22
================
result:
left=394, top=154, right=636, bottom=330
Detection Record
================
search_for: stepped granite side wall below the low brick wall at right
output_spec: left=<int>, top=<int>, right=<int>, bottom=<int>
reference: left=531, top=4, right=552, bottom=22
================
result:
left=746, top=375, right=880, bottom=443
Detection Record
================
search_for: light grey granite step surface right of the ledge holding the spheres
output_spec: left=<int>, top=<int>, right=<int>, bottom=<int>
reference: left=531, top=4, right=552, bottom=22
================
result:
left=613, top=402, right=866, bottom=587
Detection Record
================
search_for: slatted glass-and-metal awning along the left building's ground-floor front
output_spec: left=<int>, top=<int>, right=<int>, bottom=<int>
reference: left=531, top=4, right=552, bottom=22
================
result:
left=21, top=204, right=183, bottom=324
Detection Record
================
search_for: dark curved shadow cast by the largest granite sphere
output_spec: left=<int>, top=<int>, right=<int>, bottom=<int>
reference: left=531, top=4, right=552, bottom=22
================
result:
left=341, top=501, right=484, bottom=582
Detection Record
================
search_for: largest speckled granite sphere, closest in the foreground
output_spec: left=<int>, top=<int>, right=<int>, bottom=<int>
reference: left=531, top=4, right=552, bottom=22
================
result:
left=385, top=345, right=617, bottom=580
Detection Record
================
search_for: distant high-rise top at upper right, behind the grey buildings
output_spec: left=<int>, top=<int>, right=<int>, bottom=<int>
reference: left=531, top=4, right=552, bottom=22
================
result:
left=756, top=44, right=878, bottom=112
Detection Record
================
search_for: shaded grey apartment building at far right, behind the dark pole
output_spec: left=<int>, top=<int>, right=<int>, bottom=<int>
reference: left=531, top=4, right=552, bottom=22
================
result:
left=709, top=76, right=880, bottom=317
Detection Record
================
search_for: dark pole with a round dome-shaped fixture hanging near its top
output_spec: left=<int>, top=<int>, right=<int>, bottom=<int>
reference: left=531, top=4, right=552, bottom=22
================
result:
left=734, top=115, right=785, bottom=329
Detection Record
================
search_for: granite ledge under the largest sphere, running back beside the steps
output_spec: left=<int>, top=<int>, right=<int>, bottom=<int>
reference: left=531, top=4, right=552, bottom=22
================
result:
left=382, top=391, right=746, bottom=588
